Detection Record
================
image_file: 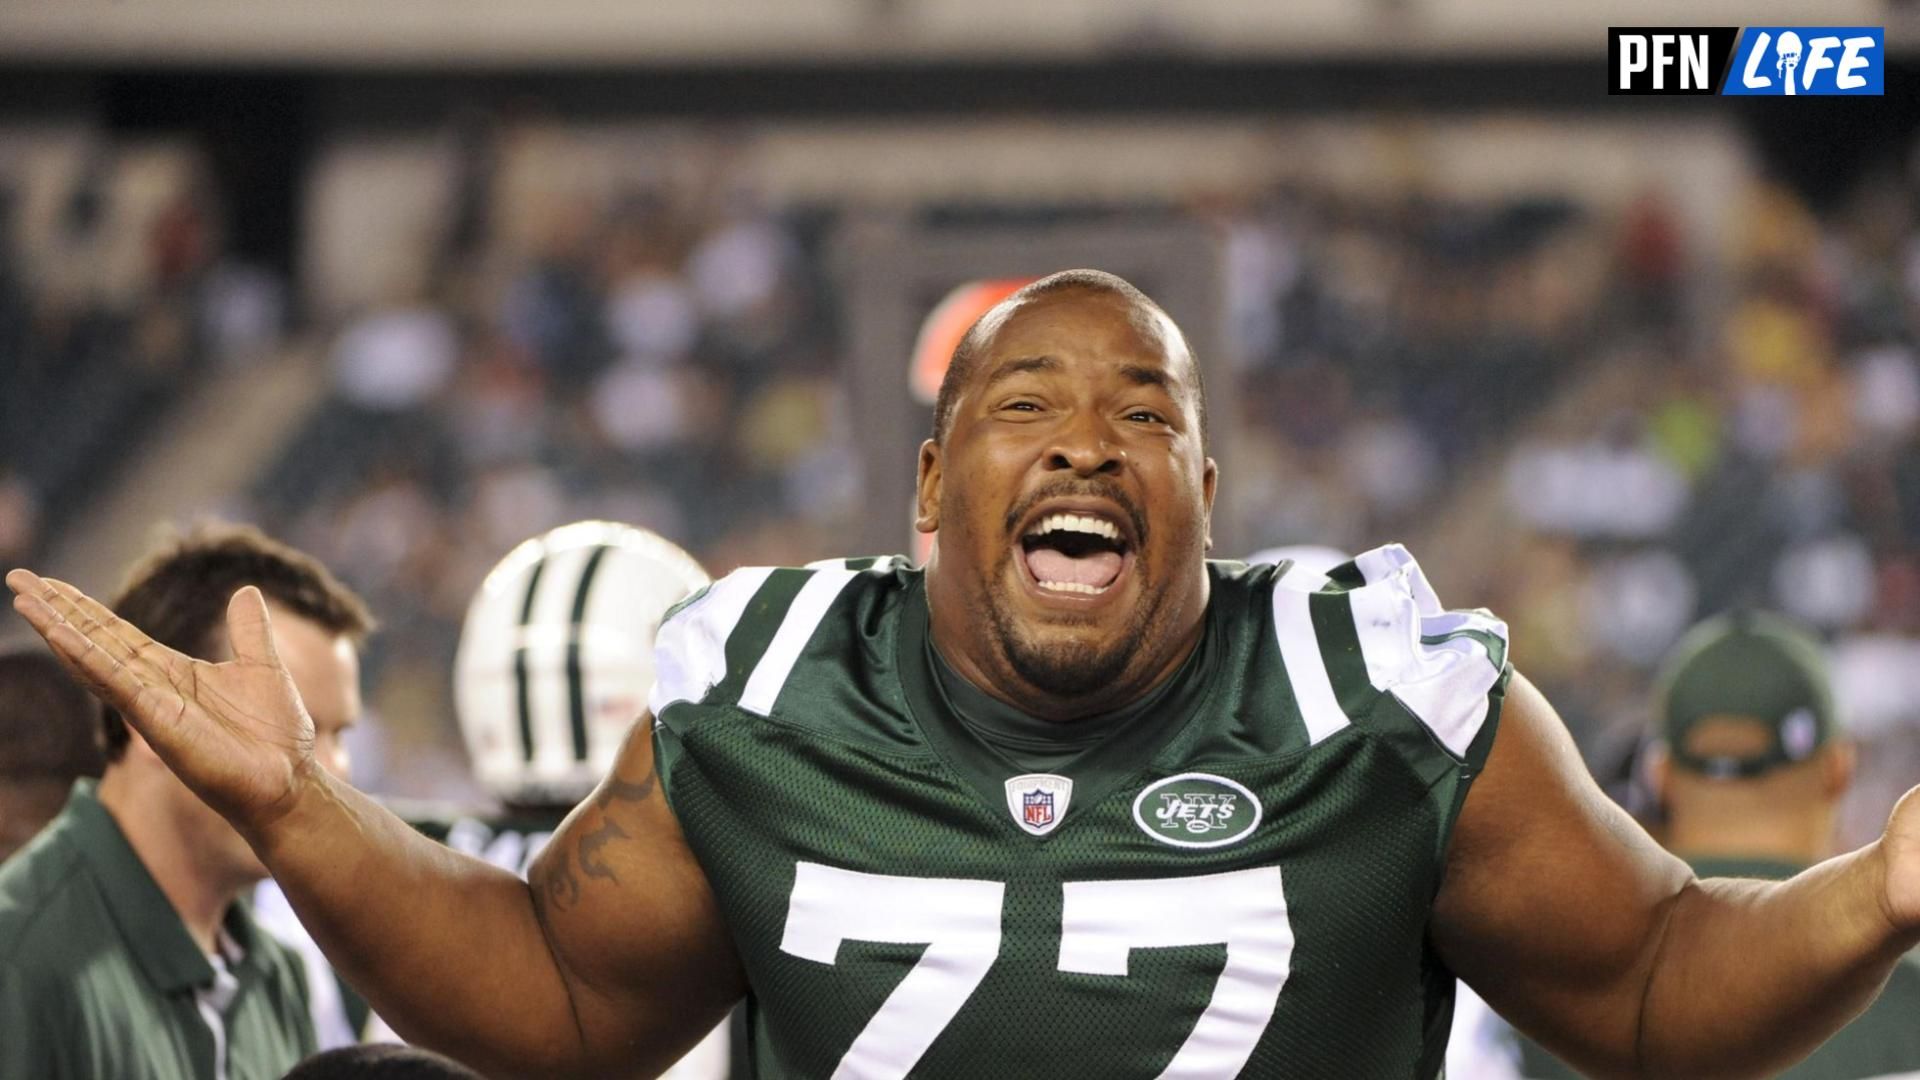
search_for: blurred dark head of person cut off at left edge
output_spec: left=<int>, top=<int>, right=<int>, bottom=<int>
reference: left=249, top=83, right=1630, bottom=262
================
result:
left=0, top=648, right=106, bottom=863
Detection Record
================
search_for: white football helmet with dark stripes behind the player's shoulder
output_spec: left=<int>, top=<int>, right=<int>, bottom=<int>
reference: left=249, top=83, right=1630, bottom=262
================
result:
left=453, top=521, right=708, bottom=807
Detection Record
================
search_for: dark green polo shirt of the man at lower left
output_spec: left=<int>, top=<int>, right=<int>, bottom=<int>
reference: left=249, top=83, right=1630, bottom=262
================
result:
left=0, top=780, right=313, bottom=1080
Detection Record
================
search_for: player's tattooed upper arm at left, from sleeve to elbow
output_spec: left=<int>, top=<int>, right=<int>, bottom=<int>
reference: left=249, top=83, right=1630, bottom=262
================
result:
left=530, top=717, right=745, bottom=1068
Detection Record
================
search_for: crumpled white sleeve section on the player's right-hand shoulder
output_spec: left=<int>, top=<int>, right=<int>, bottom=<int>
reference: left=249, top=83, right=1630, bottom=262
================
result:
left=1346, top=544, right=1507, bottom=757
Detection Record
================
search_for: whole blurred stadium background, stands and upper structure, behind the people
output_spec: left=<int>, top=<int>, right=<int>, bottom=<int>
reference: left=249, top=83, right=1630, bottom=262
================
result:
left=0, top=0, right=1920, bottom=840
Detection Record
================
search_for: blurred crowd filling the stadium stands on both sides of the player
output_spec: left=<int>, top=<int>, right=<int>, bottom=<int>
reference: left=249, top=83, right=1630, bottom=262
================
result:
left=0, top=113, right=1920, bottom=826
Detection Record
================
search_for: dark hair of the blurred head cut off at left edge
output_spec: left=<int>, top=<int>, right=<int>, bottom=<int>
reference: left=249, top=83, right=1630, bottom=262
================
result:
left=0, top=646, right=106, bottom=784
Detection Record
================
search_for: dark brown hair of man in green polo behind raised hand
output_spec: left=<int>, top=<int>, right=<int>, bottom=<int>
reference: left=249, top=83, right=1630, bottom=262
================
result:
left=104, top=523, right=374, bottom=761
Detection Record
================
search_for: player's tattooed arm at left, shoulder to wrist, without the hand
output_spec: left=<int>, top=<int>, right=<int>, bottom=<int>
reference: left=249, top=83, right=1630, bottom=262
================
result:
left=270, top=719, right=745, bottom=1076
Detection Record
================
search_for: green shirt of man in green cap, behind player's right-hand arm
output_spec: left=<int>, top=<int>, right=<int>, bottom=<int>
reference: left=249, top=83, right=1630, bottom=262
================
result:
left=1519, top=859, right=1920, bottom=1080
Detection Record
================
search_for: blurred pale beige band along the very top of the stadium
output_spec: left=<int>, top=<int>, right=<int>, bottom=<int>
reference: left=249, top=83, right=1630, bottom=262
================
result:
left=0, top=0, right=1910, bottom=67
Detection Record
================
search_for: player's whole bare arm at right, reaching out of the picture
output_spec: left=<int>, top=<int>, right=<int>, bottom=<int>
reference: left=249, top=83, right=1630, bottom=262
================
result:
left=1434, top=676, right=1920, bottom=1078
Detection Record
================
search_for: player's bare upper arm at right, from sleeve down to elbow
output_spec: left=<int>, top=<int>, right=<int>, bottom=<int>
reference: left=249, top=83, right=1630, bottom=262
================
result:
left=1432, top=676, right=1692, bottom=1072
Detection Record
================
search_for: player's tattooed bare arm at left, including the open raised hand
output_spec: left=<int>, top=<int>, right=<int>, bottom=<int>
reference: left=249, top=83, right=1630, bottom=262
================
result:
left=8, top=573, right=741, bottom=1076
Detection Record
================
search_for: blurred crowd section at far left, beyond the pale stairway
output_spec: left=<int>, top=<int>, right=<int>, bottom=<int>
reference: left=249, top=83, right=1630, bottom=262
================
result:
left=0, top=131, right=238, bottom=559
